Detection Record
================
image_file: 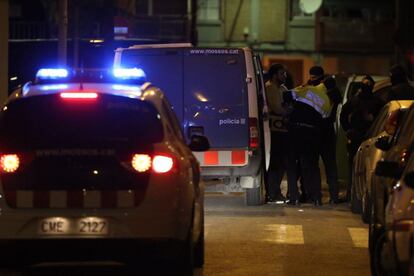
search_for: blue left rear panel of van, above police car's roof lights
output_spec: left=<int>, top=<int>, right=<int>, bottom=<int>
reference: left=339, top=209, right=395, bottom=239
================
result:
left=119, top=49, right=184, bottom=122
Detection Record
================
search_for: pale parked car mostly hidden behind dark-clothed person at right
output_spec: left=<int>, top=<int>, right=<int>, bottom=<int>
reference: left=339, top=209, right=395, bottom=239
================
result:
left=335, top=74, right=391, bottom=191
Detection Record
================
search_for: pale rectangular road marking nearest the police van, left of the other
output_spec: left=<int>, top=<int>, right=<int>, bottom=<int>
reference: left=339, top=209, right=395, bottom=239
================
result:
left=264, top=224, right=305, bottom=244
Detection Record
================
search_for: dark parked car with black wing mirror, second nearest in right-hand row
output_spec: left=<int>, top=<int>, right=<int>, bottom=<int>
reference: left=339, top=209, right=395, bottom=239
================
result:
left=369, top=105, right=414, bottom=271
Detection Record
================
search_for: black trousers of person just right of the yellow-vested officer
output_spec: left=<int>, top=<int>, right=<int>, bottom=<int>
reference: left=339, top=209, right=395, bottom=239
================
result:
left=320, top=124, right=339, bottom=200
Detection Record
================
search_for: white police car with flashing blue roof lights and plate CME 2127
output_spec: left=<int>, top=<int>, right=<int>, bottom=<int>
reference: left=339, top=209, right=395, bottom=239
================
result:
left=0, top=68, right=209, bottom=275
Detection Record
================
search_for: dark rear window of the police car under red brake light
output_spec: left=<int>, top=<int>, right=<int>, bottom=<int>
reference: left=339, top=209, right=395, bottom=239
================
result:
left=0, top=94, right=163, bottom=150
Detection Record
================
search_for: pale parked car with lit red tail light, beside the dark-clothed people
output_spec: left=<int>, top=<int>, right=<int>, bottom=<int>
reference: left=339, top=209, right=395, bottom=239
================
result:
left=351, top=101, right=413, bottom=223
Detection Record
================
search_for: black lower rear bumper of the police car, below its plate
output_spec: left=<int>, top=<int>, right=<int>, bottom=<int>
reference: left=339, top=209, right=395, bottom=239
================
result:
left=0, top=239, right=184, bottom=266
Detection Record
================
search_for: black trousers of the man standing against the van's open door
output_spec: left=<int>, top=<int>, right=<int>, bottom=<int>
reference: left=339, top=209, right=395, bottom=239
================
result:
left=267, top=131, right=288, bottom=198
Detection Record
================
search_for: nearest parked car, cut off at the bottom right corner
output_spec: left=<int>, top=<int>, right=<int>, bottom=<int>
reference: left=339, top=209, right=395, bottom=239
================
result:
left=376, top=148, right=414, bottom=275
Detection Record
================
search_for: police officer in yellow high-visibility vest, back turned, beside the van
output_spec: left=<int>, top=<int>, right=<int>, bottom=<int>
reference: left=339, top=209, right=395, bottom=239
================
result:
left=286, top=80, right=331, bottom=206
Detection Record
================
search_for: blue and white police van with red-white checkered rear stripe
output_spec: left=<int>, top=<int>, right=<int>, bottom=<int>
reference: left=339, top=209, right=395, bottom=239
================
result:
left=114, top=43, right=270, bottom=205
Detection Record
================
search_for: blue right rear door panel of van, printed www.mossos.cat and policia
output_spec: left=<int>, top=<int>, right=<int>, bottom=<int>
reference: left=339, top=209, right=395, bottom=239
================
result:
left=183, top=48, right=249, bottom=149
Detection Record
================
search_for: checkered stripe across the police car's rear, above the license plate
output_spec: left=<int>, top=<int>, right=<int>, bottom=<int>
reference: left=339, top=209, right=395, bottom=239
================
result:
left=4, top=190, right=144, bottom=209
